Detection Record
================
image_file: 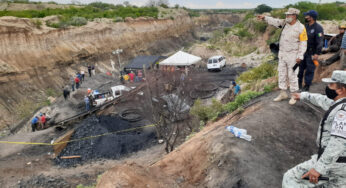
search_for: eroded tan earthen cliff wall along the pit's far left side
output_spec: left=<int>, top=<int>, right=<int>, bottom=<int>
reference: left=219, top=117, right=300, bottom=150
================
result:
left=0, top=15, right=241, bottom=129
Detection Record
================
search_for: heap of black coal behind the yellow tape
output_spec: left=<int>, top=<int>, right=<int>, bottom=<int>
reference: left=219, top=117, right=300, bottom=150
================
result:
left=55, top=116, right=157, bottom=167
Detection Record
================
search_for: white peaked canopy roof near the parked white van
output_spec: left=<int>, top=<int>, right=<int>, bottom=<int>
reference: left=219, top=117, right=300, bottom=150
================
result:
left=160, top=51, right=202, bottom=66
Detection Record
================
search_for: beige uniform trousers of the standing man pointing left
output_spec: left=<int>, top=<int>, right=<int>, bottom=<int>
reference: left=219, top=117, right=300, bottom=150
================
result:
left=278, top=53, right=299, bottom=93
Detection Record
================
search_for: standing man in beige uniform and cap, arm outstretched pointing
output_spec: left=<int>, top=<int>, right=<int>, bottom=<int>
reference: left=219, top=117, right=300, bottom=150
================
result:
left=257, top=8, right=308, bottom=105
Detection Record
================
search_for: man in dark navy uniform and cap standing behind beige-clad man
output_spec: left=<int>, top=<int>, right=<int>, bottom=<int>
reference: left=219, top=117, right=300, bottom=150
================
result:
left=298, top=10, right=324, bottom=91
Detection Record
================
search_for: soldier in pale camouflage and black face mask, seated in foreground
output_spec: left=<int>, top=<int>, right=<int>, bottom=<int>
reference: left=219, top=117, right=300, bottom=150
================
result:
left=282, top=70, right=346, bottom=188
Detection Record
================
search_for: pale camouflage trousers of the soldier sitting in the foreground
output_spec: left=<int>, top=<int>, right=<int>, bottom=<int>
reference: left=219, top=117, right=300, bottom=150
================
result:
left=282, top=155, right=346, bottom=188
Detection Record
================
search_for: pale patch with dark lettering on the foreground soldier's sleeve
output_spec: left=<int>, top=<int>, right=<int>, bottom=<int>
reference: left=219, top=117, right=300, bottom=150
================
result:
left=330, top=110, right=346, bottom=138
